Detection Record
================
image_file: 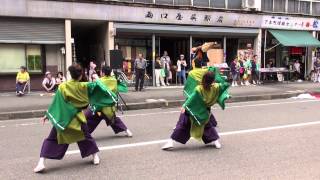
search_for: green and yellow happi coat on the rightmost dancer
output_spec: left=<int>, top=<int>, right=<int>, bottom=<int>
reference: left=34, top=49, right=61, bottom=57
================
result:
left=183, top=67, right=230, bottom=141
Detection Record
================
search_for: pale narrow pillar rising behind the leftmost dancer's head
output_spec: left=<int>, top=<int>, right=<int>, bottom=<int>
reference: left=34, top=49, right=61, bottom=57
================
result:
left=65, top=19, right=72, bottom=79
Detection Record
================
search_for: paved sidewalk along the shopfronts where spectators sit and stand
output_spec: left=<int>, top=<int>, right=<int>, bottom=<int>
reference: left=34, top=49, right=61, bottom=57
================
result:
left=0, top=82, right=320, bottom=113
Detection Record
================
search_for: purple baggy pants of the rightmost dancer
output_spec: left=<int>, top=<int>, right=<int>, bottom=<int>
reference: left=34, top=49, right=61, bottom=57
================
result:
left=171, top=113, right=219, bottom=144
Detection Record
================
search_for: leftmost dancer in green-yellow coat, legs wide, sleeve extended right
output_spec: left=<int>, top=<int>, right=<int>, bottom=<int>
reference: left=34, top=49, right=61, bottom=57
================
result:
left=34, top=64, right=117, bottom=172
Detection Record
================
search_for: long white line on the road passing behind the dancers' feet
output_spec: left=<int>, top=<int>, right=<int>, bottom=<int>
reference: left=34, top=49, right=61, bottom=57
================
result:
left=66, top=121, right=320, bottom=155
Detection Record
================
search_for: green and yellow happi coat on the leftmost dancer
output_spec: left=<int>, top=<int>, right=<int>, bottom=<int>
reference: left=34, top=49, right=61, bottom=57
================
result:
left=46, top=80, right=117, bottom=144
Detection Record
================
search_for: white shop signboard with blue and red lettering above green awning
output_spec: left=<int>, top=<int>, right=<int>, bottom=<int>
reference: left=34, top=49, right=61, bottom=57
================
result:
left=261, top=16, right=320, bottom=31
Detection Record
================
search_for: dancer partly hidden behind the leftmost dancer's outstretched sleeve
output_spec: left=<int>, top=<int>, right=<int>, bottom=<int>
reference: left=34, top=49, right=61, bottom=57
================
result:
left=85, top=66, right=132, bottom=137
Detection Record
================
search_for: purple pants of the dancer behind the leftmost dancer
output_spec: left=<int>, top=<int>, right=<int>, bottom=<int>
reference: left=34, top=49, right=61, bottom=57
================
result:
left=85, top=110, right=128, bottom=134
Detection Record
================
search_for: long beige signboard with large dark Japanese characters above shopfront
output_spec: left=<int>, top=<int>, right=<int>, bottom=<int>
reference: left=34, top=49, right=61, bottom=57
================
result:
left=125, top=7, right=261, bottom=28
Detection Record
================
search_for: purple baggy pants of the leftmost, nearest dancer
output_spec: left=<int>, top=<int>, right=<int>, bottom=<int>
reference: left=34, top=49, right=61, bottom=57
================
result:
left=40, top=124, right=99, bottom=159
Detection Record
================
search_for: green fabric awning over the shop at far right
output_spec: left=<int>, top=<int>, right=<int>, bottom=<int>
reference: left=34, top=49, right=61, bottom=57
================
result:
left=269, top=30, right=320, bottom=47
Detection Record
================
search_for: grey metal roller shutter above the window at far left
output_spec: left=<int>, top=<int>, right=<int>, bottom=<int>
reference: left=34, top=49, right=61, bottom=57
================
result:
left=0, top=18, right=65, bottom=44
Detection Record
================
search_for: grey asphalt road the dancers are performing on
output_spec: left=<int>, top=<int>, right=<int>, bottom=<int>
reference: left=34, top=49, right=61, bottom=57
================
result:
left=0, top=100, right=320, bottom=180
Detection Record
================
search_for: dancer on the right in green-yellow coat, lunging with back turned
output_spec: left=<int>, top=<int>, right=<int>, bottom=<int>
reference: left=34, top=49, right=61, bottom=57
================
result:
left=162, top=65, right=229, bottom=150
